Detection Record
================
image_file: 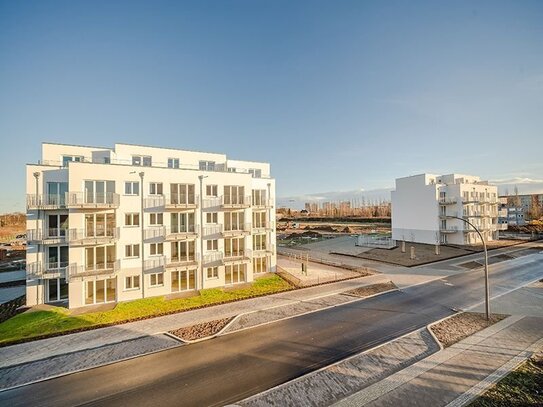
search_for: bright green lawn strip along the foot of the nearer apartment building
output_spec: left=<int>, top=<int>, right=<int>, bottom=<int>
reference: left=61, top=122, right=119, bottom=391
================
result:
left=0, top=275, right=292, bottom=345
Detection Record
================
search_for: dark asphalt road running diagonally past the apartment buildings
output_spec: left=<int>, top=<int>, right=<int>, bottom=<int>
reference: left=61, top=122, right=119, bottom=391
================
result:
left=0, top=254, right=543, bottom=406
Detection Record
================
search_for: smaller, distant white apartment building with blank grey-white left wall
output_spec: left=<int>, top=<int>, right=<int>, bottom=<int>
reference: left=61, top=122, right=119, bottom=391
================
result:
left=392, top=174, right=499, bottom=245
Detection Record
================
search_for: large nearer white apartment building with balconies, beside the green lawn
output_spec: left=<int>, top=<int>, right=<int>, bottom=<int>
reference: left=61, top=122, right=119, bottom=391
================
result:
left=26, top=143, right=276, bottom=308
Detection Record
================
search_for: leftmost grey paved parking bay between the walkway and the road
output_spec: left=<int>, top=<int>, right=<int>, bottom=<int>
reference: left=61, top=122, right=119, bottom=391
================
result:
left=0, top=335, right=182, bottom=389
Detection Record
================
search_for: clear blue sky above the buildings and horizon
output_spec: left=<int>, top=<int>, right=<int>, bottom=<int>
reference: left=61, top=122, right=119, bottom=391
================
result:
left=0, top=0, right=543, bottom=211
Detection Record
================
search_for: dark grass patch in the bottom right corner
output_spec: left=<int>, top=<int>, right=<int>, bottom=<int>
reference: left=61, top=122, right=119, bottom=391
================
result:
left=470, top=358, right=543, bottom=407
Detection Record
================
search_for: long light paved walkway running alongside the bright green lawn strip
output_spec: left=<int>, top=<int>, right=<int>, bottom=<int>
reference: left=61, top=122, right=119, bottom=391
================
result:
left=0, top=275, right=388, bottom=368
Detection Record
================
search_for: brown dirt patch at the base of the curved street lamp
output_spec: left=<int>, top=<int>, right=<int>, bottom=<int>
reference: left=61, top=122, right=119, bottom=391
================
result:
left=430, top=312, right=508, bottom=348
